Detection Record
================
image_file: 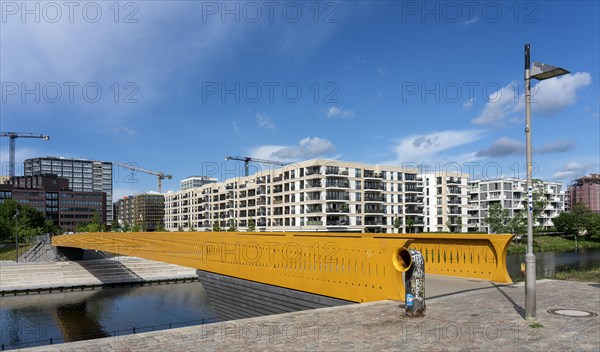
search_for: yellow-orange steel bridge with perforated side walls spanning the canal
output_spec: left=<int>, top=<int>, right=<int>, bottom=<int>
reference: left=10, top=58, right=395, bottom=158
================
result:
left=52, top=232, right=513, bottom=302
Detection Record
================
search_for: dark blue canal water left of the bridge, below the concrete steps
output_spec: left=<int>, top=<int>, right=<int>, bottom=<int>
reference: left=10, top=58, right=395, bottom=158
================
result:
left=0, top=282, right=216, bottom=349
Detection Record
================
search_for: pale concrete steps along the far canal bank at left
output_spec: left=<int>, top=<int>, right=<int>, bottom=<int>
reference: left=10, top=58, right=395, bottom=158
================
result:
left=0, top=258, right=197, bottom=294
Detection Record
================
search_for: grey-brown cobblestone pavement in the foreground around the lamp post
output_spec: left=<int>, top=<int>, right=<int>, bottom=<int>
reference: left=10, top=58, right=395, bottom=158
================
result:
left=21, top=280, right=600, bottom=352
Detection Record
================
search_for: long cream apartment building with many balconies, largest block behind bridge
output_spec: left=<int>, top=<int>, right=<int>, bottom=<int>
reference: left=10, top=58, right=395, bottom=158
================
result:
left=165, top=159, right=424, bottom=233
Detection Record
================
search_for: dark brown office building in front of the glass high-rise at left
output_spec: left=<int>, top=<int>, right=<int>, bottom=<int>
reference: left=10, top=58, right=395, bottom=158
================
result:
left=0, top=175, right=107, bottom=231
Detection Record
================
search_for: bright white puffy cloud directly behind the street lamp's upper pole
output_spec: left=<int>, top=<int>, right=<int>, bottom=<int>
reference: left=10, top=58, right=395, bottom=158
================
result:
left=471, top=72, right=592, bottom=126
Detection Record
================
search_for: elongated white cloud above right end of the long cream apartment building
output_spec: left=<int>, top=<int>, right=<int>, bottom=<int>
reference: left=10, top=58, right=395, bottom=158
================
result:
left=395, top=130, right=483, bottom=163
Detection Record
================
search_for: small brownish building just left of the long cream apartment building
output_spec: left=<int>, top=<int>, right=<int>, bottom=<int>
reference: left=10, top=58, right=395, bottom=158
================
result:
left=116, top=193, right=165, bottom=231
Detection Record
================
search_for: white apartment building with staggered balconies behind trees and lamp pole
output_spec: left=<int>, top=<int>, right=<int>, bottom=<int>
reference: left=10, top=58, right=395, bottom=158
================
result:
left=467, top=178, right=565, bottom=232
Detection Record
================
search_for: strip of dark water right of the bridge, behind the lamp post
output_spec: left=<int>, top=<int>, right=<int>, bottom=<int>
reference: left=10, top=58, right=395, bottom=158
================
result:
left=506, top=248, right=600, bottom=281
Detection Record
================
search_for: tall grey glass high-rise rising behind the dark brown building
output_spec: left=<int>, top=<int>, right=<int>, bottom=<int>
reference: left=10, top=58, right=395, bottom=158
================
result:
left=23, top=156, right=113, bottom=225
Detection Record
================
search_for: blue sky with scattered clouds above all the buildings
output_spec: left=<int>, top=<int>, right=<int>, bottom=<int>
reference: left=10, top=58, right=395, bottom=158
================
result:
left=0, top=1, right=600, bottom=198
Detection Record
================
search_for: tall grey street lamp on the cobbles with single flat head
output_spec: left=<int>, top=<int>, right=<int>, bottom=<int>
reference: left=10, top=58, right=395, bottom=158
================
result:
left=525, top=44, right=569, bottom=320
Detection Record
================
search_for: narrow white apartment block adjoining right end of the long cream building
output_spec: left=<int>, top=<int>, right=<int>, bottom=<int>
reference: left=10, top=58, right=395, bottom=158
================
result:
left=422, top=172, right=469, bottom=232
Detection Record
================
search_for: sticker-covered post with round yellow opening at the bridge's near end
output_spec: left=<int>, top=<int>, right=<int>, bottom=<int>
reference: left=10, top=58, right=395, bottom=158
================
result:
left=396, top=248, right=426, bottom=318
